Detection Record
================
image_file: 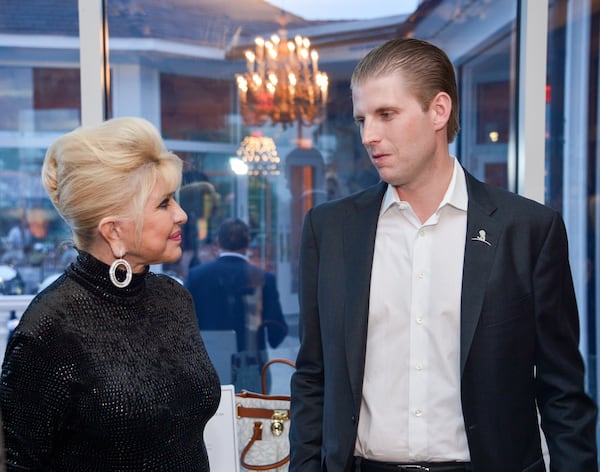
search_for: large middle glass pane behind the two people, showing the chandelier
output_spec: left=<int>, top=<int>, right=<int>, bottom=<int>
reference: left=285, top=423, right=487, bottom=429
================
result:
left=99, top=0, right=516, bottom=394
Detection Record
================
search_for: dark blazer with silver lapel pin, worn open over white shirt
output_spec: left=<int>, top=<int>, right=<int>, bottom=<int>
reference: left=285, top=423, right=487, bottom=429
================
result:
left=290, top=173, right=597, bottom=472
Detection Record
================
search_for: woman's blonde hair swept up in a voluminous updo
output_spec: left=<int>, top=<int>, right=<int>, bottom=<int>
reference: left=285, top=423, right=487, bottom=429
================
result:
left=42, top=118, right=182, bottom=250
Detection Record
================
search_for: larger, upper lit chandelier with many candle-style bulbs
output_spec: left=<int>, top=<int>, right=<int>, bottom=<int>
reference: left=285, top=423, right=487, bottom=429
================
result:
left=236, top=30, right=329, bottom=129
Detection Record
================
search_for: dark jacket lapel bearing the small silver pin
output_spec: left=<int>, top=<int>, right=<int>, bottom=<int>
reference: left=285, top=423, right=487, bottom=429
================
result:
left=460, top=172, right=503, bottom=375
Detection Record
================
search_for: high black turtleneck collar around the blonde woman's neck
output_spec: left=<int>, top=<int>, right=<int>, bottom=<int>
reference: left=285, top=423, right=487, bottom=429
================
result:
left=67, top=249, right=149, bottom=303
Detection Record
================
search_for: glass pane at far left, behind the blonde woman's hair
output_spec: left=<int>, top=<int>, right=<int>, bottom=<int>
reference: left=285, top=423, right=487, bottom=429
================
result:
left=0, top=1, right=81, bottom=298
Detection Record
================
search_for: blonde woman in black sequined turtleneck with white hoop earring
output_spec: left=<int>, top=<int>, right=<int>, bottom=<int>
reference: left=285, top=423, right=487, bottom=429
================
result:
left=0, top=118, right=220, bottom=472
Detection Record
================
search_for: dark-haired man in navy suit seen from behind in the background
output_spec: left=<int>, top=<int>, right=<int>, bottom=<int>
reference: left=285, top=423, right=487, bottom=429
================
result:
left=185, top=218, right=288, bottom=391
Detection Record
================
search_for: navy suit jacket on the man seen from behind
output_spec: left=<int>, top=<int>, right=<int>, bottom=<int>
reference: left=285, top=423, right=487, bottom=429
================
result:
left=185, top=256, right=288, bottom=351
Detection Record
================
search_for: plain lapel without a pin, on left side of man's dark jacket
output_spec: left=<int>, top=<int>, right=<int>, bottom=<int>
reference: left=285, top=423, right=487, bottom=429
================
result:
left=342, top=183, right=387, bottom=404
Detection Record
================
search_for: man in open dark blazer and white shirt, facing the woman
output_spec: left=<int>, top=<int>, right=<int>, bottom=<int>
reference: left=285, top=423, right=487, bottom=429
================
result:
left=290, top=39, right=597, bottom=472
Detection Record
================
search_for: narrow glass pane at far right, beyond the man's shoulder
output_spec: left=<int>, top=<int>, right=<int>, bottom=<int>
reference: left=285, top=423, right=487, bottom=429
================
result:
left=546, top=0, right=600, bottom=400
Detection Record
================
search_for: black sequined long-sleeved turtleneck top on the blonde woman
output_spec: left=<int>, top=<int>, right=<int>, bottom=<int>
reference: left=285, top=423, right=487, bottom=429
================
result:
left=0, top=252, right=220, bottom=472
